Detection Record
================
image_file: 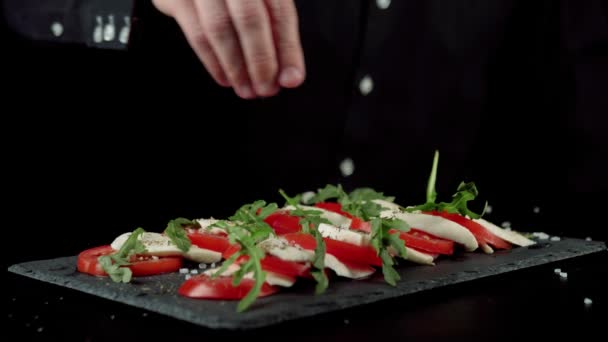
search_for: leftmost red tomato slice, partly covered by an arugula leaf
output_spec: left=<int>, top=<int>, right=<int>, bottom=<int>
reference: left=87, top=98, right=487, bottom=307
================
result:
left=77, top=246, right=182, bottom=277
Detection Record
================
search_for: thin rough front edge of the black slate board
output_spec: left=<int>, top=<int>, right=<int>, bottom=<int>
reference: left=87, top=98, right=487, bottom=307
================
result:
left=8, top=242, right=607, bottom=330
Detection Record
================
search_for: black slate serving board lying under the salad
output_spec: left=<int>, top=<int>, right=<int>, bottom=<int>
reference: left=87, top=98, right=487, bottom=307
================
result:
left=9, top=239, right=606, bottom=330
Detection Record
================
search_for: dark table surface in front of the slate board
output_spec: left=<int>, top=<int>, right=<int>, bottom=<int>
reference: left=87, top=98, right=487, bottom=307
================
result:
left=5, top=247, right=608, bottom=341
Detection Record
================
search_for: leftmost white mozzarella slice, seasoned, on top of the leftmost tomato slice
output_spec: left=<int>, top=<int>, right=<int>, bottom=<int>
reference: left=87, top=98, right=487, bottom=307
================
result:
left=111, top=232, right=222, bottom=263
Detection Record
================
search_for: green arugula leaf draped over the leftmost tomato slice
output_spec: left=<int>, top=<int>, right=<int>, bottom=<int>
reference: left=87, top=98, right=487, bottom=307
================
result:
left=97, top=228, right=146, bottom=283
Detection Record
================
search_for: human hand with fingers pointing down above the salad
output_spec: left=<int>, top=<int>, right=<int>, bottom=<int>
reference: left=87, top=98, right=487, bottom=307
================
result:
left=153, top=0, right=306, bottom=99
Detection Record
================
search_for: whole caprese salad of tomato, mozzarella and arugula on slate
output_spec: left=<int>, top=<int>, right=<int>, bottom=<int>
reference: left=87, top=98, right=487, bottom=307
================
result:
left=77, top=152, right=534, bottom=311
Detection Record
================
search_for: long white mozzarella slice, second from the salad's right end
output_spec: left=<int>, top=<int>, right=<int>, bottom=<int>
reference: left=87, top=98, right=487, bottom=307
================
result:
left=380, top=210, right=479, bottom=251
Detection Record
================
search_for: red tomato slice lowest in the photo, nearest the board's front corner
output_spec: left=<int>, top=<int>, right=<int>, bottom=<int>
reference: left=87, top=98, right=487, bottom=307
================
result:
left=177, top=275, right=279, bottom=299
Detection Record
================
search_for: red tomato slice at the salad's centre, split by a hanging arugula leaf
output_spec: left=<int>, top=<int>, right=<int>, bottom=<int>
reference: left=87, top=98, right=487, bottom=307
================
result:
left=283, top=233, right=382, bottom=266
